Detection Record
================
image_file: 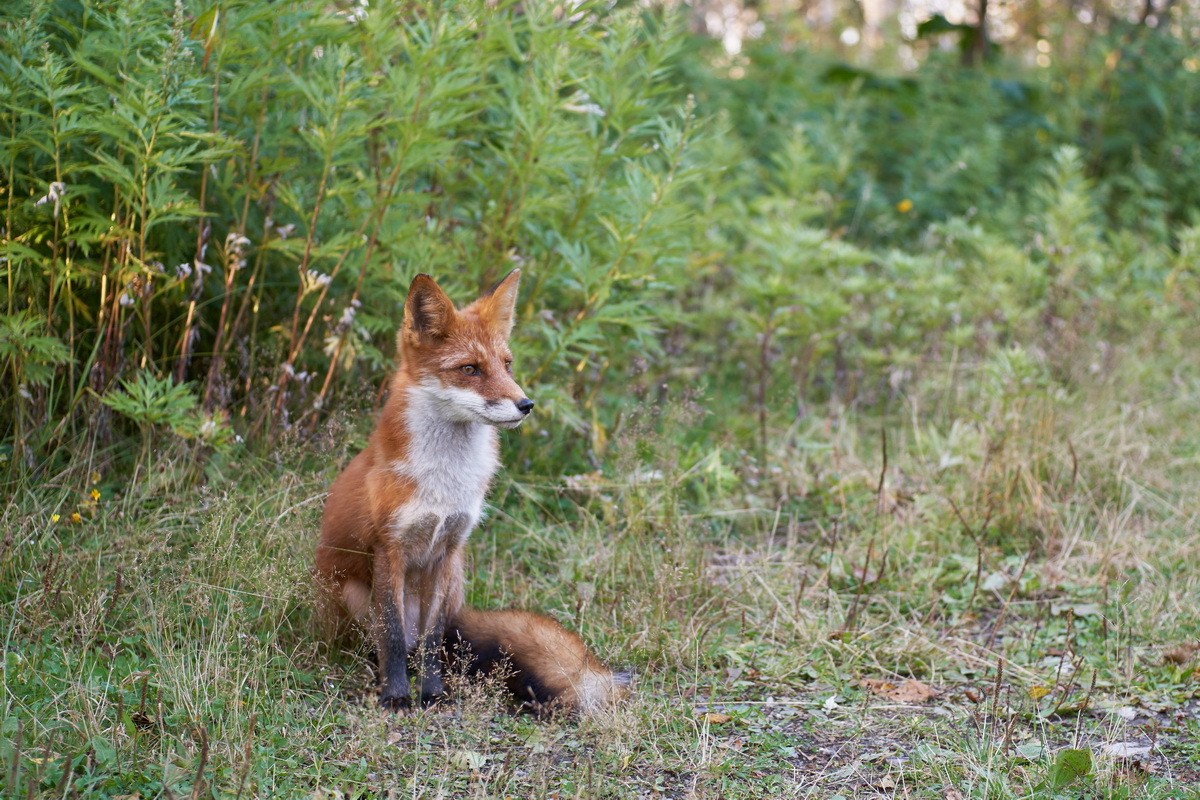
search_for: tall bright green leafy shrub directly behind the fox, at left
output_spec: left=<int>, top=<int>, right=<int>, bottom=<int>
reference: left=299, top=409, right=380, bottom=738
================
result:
left=0, top=0, right=703, bottom=474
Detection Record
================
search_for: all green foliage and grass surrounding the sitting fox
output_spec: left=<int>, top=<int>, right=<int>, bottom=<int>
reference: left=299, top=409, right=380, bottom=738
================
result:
left=0, top=0, right=1200, bottom=798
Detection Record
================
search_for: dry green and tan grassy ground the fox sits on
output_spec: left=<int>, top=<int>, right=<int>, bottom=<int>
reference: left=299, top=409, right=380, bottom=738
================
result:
left=0, top=345, right=1200, bottom=799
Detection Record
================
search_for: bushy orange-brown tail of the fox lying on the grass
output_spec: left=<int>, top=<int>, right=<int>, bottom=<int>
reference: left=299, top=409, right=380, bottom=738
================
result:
left=445, top=608, right=631, bottom=715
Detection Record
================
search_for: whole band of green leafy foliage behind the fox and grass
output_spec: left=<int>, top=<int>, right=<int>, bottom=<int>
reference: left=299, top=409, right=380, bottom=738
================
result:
left=0, top=0, right=1200, bottom=476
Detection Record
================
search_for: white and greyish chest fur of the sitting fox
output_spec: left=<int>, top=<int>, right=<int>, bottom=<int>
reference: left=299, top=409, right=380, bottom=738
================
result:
left=391, top=387, right=499, bottom=567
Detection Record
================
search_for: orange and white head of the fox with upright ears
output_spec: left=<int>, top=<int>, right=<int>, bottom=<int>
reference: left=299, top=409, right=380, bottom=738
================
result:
left=397, top=270, right=533, bottom=428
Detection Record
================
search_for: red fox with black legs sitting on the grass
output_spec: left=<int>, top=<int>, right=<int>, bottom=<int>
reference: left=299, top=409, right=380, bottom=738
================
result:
left=317, top=270, right=626, bottom=712
